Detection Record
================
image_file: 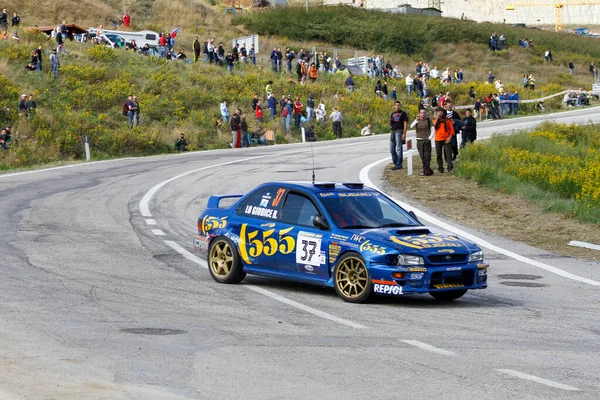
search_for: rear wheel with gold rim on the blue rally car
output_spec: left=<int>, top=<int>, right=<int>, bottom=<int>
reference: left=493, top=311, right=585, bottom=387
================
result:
left=208, top=237, right=246, bottom=283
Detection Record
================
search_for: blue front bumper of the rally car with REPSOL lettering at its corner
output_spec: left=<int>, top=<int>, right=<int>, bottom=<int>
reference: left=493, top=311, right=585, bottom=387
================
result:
left=369, top=263, right=489, bottom=295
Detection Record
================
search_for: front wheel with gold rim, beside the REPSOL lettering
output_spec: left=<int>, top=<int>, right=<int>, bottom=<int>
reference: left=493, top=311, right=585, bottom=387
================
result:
left=333, top=253, right=373, bottom=303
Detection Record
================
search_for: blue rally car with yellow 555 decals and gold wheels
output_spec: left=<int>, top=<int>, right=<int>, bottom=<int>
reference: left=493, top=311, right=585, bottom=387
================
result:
left=194, top=182, right=488, bottom=303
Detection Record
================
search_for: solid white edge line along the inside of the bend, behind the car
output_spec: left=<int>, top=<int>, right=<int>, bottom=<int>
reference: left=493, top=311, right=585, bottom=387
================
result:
left=359, top=157, right=600, bottom=286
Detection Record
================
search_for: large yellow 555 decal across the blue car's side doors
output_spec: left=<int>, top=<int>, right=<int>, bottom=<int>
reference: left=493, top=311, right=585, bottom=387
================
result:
left=238, top=224, right=296, bottom=264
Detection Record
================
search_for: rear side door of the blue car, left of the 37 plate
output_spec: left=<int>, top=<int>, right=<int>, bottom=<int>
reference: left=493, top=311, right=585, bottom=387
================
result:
left=235, top=186, right=291, bottom=271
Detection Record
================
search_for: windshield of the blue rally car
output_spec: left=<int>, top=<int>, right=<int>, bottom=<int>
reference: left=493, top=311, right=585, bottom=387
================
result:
left=321, top=192, right=419, bottom=229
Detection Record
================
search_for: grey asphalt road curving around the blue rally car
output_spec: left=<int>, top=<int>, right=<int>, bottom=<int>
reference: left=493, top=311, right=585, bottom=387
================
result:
left=0, top=109, right=600, bottom=400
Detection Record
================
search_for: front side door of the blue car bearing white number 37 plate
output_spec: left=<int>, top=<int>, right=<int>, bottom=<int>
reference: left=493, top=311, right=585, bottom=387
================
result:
left=276, top=191, right=330, bottom=280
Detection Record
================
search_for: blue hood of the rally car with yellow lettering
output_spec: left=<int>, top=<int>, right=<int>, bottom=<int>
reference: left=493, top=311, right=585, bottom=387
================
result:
left=361, top=226, right=478, bottom=254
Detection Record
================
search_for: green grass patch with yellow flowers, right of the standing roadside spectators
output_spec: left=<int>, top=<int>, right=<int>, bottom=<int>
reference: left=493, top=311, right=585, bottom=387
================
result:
left=455, top=123, right=600, bottom=224
